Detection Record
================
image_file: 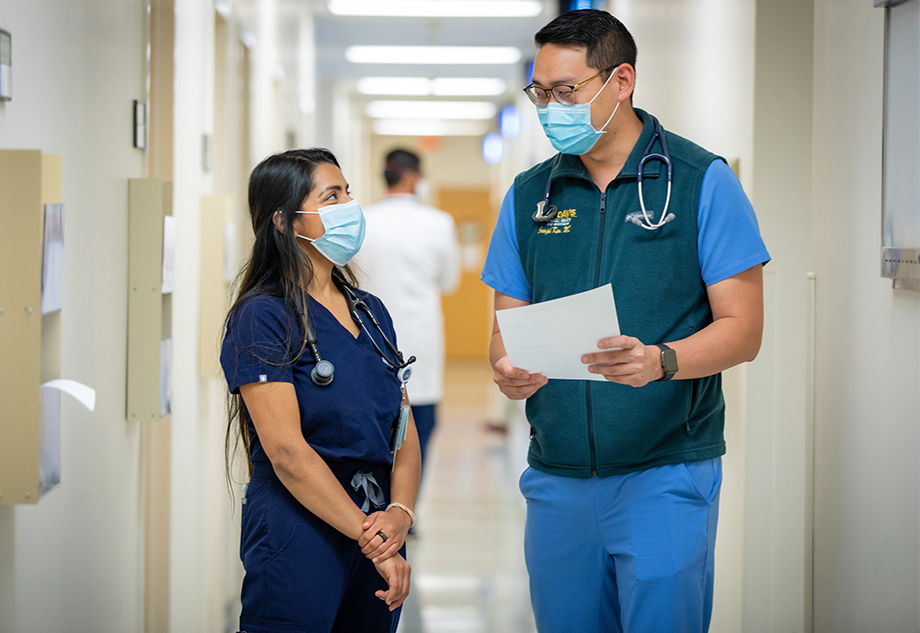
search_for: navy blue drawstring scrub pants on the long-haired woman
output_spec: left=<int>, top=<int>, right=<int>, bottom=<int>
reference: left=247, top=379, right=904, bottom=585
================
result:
left=240, top=462, right=405, bottom=633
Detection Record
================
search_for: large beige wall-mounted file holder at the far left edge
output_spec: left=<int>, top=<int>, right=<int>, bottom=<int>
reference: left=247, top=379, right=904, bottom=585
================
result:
left=0, top=150, right=63, bottom=505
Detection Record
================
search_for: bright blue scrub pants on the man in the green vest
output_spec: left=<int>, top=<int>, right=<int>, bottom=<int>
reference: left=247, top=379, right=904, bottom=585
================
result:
left=520, top=457, right=722, bottom=633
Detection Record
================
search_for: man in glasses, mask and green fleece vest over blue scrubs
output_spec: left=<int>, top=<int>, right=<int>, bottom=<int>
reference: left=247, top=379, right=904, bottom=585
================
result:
left=482, top=9, right=770, bottom=633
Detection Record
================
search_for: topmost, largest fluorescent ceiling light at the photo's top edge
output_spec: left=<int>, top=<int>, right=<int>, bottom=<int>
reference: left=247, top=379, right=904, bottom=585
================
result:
left=329, top=0, right=543, bottom=18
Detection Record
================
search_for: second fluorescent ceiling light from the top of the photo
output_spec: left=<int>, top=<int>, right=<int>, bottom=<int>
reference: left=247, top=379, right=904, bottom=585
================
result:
left=345, top=46, right=521, bottom=65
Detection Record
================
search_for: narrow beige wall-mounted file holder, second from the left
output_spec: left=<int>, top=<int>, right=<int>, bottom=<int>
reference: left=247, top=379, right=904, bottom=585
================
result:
left=125, top=178, right=172, bottom=422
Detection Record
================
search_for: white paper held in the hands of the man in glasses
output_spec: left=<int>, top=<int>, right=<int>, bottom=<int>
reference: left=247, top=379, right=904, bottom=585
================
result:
left=495, top=284, right=620, bottom=380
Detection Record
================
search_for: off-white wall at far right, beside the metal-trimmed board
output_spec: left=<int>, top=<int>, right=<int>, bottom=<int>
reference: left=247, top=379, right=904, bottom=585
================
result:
left=812, top=0, right=920, bottom=633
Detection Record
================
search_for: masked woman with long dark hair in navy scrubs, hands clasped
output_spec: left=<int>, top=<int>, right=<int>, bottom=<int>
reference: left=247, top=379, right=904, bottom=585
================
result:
left=221, top=149, right=420, bottom=633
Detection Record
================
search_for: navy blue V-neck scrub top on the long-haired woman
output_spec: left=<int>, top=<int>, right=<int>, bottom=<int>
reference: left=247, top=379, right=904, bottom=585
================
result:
left=220, top=291, right=402, bottom=467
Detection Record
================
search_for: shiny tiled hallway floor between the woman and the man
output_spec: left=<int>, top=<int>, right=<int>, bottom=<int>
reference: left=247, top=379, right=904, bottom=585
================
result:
left=399, top=361, right=536, bottom=633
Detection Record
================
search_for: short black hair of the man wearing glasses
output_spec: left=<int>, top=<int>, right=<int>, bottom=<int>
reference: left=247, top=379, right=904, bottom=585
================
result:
left=533, top=9, right=636, bottom=76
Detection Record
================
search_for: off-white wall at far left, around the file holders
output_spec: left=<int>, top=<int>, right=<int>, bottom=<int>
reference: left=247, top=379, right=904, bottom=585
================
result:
left=0, top=0, right=146, bottom=633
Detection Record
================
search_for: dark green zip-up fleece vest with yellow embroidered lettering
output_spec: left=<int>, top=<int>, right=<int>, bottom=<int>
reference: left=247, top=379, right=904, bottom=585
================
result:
left=514, top=109, right=725, bottom=478
